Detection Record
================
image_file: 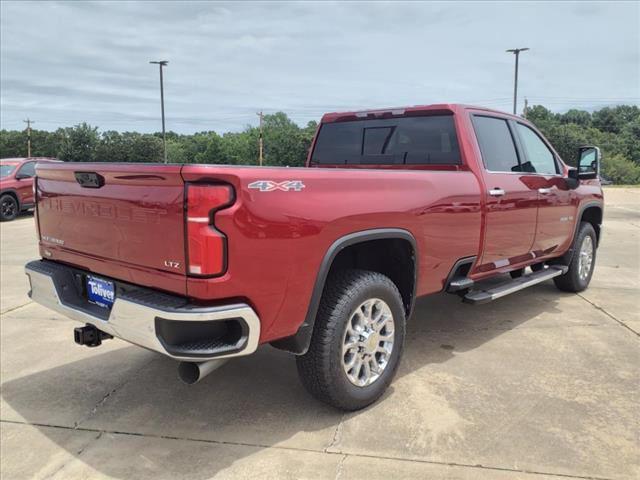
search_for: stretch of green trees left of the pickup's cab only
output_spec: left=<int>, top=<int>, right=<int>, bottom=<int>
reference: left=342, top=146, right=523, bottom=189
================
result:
left=0, top=112, right=317, bottom=167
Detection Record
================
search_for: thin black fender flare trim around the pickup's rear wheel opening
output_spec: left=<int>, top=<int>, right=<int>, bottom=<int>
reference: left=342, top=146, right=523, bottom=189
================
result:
left=271, top=228, right=419, bottom=355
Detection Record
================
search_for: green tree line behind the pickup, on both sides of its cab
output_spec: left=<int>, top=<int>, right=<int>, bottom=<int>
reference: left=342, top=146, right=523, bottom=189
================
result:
left=0, top=105, right=640, bottom=184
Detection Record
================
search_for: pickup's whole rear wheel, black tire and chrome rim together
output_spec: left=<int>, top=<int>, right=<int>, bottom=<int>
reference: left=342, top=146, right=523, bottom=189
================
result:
left=296, top=270, right=405, bottom=410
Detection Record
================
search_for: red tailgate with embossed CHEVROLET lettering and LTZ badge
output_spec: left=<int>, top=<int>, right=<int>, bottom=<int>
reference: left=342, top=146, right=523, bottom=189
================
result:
left=37, top=163, right=186, bottom=290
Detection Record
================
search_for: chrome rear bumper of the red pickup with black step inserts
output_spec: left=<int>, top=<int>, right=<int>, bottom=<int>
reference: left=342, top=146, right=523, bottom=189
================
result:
left=25, top=260, right=260, bottom=362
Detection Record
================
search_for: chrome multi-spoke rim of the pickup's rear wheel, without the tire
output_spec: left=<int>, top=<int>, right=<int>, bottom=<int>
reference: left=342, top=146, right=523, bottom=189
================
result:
left=342, top=298, right=395, bottom=387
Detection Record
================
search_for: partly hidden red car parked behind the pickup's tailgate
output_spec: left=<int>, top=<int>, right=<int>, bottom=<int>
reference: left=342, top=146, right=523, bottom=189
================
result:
left=0, top=157, right=57, bottom=222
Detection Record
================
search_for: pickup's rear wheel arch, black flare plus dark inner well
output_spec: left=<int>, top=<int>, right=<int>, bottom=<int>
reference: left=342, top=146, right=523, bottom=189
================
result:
left=271, top=228, right=418, bottom=355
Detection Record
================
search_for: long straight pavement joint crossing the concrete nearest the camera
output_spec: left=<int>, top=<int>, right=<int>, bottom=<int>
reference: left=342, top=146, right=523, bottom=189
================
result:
left=0, top=420, right=611, bottom=480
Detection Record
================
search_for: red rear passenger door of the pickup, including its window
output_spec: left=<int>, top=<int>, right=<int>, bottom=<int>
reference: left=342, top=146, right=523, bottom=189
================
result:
left=472, top=115, right=538, bottom=272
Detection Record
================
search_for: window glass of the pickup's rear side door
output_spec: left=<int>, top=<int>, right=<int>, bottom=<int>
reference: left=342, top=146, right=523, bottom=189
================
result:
left=473, top=115, right=521, bottom=172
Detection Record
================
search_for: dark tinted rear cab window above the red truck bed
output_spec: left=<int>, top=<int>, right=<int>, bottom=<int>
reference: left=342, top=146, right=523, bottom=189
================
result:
left=311, top=115, right=462, bottom=165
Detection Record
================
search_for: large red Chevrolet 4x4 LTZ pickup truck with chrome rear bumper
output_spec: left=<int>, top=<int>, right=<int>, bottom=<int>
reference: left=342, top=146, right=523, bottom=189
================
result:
left=26, top=104, right=603, bottom=410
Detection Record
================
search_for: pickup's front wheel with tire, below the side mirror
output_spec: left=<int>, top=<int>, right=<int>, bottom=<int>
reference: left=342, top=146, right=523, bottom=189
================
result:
left=553, top=222, right=598, bottom=292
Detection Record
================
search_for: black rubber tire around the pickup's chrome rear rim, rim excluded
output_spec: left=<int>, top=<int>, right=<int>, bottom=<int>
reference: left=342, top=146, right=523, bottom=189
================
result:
left=296, top=270, right=406, bottom=411
